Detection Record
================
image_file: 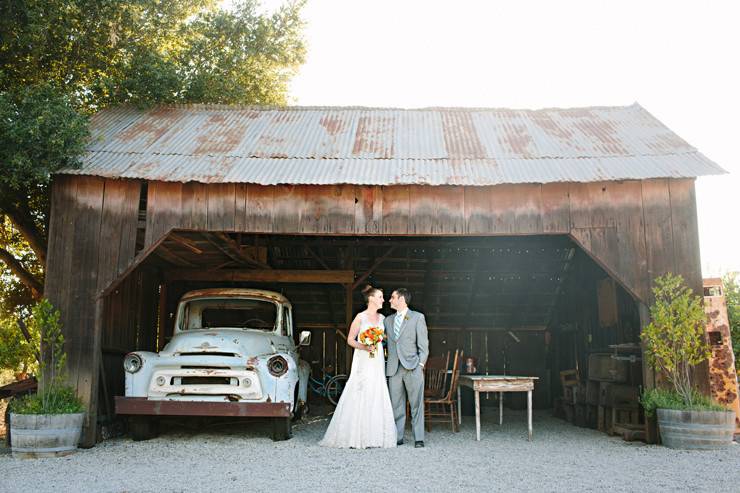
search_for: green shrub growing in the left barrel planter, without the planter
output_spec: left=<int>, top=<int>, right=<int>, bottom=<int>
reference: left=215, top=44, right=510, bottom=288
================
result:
left=11, top=299, right=84, bottom=414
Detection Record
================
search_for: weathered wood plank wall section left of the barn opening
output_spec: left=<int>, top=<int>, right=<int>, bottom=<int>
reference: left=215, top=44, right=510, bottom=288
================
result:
left=44, top=176, right=140, bottom=446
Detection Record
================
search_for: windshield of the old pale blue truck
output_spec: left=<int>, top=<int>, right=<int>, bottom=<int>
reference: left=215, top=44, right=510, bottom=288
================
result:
left=181, top=298, right=278, bottom=331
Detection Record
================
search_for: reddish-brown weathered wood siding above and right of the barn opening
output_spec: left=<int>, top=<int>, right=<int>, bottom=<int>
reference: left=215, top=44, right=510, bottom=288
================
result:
left=146, top=179, right=701, bottom=300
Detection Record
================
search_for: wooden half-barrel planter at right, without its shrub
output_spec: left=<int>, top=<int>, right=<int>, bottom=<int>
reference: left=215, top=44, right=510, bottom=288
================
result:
left=657, top=409, right=735, bottom=450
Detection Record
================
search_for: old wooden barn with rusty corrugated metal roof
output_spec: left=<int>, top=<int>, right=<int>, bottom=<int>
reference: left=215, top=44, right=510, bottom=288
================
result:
left=45, top=104, right=723, bottom=446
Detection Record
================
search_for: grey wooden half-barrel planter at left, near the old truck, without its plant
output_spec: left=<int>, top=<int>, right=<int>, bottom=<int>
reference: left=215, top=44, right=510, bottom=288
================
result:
left=10, top=413, right=85, bottom=458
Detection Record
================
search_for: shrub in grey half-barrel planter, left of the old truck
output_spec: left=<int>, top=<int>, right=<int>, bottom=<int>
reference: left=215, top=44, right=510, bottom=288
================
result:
left=10, top=300, right=85, bottom=457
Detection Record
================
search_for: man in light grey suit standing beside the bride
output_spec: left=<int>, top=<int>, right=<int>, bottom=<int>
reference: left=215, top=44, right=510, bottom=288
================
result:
left=384, top=288, right=429, bottom=448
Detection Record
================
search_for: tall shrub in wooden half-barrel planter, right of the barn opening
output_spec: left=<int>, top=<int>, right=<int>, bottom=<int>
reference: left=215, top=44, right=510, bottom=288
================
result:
left=641, top=273, right=735, bottom=449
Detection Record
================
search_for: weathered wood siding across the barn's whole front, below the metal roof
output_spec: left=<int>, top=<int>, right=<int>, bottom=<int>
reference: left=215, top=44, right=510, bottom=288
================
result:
left=45, top=176, right=702, bottom=445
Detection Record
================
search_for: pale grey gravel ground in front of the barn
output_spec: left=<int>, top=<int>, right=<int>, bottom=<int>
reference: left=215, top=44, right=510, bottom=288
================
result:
left=0, top=411, right=740, bottom=493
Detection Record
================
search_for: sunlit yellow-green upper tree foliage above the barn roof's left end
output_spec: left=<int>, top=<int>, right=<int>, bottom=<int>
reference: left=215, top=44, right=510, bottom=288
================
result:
left=0, top=0, right=306, bottom=111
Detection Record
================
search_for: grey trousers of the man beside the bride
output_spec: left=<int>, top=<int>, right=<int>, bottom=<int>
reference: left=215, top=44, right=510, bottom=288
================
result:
left=388, top=365, right=424, bottom=442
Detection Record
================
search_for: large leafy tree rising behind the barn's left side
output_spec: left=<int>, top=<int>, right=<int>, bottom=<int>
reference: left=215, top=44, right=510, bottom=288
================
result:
left=0, top=0, right=306, bottom=354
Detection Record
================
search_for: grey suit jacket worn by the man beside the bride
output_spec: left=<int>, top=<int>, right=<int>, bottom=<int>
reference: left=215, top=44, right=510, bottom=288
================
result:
left=383, top=309, right=429, bottom=377
